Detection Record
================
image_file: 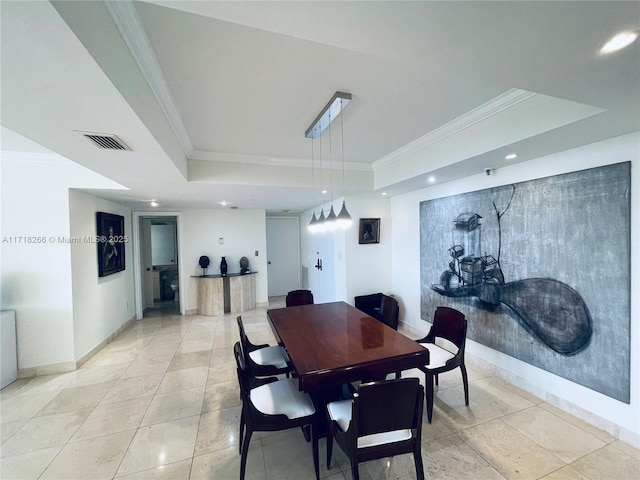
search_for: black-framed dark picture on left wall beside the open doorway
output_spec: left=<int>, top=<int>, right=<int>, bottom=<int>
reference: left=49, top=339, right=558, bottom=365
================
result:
left=96, top=212, right=127, bottom=277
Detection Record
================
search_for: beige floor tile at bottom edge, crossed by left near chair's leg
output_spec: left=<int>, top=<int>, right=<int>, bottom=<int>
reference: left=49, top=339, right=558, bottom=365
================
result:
left=190, top=441, right=267, bottom=480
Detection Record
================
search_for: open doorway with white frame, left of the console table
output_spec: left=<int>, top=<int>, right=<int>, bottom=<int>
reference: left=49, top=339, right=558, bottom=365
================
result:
left=134, top=213, right=183, bottom=319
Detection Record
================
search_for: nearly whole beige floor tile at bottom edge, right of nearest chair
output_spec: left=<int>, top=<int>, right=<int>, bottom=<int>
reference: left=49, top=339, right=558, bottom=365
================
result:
left=459, top=419, right=565, bottom=480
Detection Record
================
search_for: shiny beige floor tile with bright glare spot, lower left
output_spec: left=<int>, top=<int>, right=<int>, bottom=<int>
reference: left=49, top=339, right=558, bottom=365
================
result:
left=117, top=415, right=200, bottom=476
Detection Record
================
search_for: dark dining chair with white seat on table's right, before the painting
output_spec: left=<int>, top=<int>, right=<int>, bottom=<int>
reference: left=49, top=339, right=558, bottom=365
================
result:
left=416, top=307, right=469, bottom=423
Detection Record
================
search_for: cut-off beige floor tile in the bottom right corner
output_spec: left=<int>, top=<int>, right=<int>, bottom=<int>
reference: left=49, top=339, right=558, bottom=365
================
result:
left=571, top=440, right=640, bottom=480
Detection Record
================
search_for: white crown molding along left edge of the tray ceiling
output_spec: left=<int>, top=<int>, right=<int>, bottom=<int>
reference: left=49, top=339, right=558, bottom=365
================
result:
left=104, top=1, right=193, bottom=156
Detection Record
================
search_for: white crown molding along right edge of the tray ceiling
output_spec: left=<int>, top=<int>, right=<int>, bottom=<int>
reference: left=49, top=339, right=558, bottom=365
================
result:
left=373, top=88, right=537, bottom=171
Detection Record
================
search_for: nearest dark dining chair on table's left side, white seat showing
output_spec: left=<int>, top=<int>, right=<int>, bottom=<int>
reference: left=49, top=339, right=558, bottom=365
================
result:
left=233, top=342, right=320, bottom=480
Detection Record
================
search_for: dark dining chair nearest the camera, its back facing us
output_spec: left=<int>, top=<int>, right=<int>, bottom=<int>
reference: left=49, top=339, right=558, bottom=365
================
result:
left=326, top=378, right=424, bottom=480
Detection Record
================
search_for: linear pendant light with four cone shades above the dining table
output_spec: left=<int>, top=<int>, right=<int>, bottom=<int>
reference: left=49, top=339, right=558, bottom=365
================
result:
left=305, top=92, right=353, bottom=232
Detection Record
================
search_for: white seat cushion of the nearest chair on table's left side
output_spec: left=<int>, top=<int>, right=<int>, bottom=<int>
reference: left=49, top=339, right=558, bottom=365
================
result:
left=249, top=378, right=316, bottom=420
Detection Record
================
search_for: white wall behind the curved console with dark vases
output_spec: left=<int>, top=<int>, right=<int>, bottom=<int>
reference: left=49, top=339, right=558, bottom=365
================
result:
left=178, top=209, right=269, bottom=312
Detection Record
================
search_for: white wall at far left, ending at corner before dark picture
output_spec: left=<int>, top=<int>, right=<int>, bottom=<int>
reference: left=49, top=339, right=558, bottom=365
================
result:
left=0, top=152, right=126, bottom=376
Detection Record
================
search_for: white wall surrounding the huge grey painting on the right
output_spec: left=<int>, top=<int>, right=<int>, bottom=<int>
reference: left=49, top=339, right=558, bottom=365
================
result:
left=391, top=133, right=640, bottom=446
